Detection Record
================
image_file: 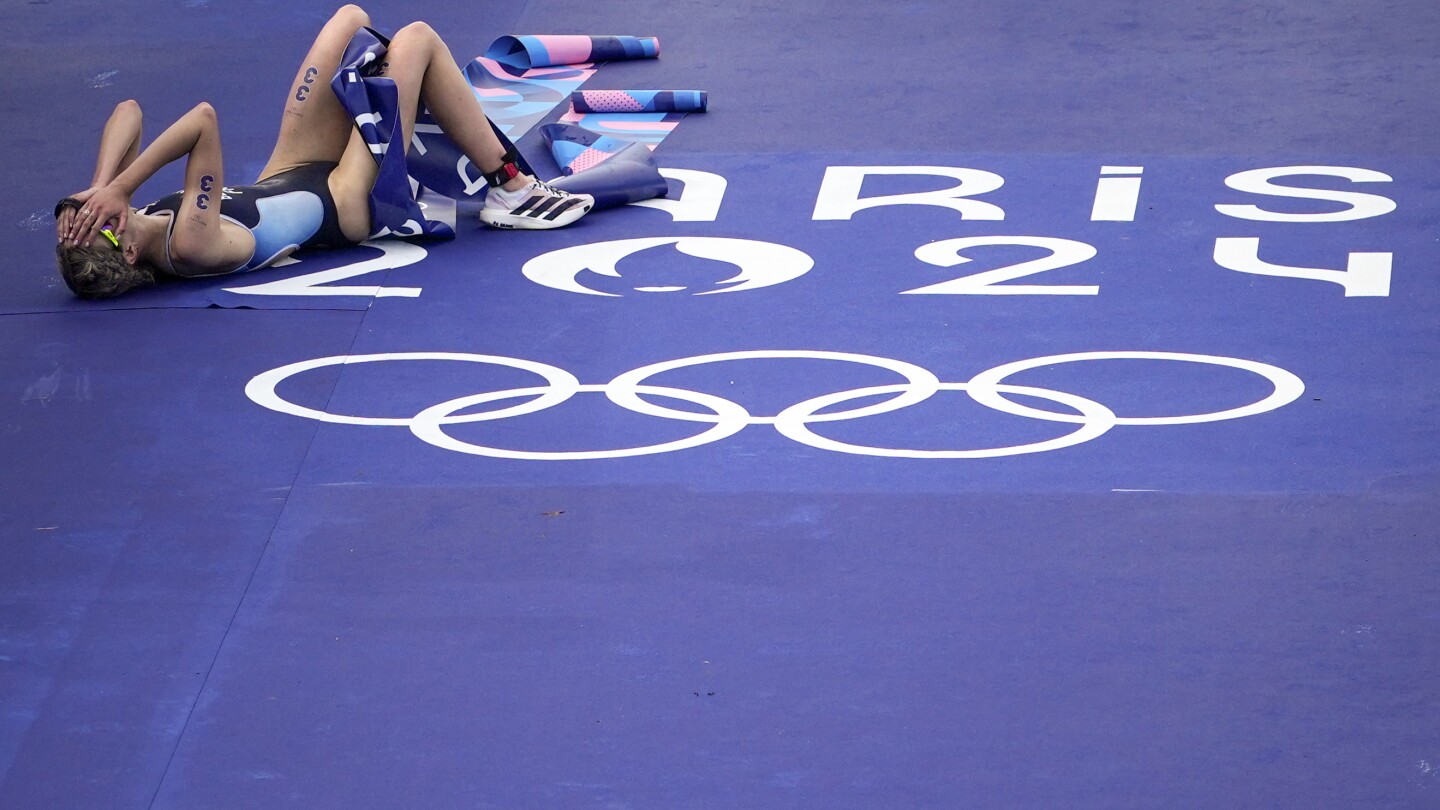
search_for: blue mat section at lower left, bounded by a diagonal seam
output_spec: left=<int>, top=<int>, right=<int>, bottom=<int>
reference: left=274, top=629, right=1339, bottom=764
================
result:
left=0, top=305, right=360, bottom=807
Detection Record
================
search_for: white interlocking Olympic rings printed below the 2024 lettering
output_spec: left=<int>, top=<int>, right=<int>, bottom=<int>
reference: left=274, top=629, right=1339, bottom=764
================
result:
left=245, top=350, right=1305, bottom=461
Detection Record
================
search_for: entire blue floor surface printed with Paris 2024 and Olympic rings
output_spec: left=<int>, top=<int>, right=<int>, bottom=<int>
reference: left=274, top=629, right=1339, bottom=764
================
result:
left=0, top=0, right=1440, bottom=810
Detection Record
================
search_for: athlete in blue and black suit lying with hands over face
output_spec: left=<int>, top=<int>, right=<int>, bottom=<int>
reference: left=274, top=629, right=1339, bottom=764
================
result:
left=56, top=6, right=595, bottom=298
